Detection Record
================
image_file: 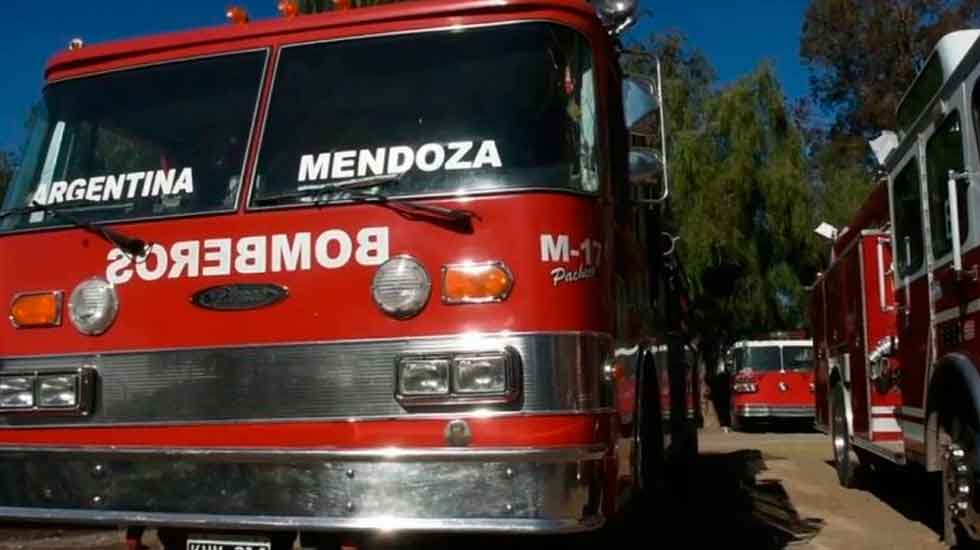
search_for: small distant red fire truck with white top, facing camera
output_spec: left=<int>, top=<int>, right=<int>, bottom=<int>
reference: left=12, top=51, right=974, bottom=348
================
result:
left=726, top=333, right=814, bottom=430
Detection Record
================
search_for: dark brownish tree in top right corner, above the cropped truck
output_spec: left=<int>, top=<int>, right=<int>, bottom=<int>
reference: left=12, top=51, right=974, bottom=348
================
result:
left=800, top=0, right=980, bottom=138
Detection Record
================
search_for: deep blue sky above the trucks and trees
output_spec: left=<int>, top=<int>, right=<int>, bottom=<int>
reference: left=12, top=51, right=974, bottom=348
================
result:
left=0, top=0, right=808, bottom=150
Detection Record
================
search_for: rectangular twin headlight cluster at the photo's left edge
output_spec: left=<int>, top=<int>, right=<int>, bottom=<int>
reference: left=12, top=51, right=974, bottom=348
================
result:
left=0, top=368, right=94, bottom=415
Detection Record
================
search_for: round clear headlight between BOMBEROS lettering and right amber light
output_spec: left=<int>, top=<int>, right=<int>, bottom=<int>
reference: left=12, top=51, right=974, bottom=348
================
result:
left=371, top=256, right=432, bottom=319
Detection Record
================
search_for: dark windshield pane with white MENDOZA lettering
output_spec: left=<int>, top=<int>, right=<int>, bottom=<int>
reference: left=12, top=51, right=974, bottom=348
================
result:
left=252, top=23, right=599, bottom=205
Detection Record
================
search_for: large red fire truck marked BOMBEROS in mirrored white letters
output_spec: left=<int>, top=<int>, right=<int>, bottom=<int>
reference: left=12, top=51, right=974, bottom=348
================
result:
left=0, top=0, right=696, bottom=549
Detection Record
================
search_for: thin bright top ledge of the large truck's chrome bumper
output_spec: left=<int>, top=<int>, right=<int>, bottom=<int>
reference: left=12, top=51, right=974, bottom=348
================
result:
left=0, top=444, right=606, bottom=464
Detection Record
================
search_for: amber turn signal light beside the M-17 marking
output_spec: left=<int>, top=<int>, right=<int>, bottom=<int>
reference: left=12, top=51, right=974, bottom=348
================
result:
left=442, top=262, right=514, bottom=304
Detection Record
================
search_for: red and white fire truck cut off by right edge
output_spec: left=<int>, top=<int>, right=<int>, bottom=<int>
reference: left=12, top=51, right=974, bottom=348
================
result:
left=811, top=30, right=980, bottom=545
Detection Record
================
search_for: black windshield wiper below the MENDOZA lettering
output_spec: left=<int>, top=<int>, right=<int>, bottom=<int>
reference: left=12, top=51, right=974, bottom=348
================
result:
left=255, top=172, right=477, bottom=222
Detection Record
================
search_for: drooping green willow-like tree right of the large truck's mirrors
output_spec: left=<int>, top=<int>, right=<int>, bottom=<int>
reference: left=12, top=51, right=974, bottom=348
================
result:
left=629, top=34, right=820, bottom=345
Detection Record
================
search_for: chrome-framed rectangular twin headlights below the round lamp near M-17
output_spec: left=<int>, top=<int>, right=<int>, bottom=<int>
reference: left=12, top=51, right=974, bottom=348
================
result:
left=396, top=349, right=521, bottom=405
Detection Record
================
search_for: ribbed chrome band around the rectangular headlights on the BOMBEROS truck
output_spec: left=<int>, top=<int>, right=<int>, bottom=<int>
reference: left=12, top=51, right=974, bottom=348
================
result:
left=0, top=333, right=613, bottom=428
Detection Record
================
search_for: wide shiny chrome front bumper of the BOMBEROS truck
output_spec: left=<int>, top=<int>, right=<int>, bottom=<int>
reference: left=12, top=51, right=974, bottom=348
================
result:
left=0, top=446, right=606, bottom=533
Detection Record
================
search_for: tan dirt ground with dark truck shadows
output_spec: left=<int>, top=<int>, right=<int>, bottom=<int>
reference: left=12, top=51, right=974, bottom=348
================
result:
left=0, top=428, right=944, bottom=550
